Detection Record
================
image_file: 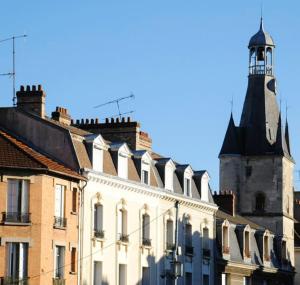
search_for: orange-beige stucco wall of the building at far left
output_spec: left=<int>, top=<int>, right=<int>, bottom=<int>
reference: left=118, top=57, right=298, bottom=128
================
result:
left=0, top=172, right=78, bottom=285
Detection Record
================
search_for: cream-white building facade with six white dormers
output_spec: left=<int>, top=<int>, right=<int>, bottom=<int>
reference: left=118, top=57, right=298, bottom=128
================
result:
left=79, top=135, right=217, bottom=285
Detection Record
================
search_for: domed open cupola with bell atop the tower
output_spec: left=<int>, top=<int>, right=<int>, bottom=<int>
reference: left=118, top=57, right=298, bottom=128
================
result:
left=248, top=18, right=275, bottom=76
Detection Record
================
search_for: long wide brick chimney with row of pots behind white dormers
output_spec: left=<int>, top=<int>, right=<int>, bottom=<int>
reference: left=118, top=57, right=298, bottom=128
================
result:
left=73, top=117, right=152, bottom=151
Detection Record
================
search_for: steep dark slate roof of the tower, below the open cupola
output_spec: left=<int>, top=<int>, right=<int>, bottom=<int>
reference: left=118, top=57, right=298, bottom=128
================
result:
left=220, top=75, right=293, bottom=161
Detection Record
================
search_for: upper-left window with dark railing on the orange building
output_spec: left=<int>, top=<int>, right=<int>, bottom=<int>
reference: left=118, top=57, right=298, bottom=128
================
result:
left=5, top=179, right=30, bottom=223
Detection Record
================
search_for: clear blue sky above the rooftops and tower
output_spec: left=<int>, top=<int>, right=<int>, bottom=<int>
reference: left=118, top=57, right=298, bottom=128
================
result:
left=0, top=0, right=300, bottom=190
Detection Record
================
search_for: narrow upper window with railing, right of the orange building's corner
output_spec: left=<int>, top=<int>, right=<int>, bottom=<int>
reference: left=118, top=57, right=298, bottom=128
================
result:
left=54, top=184, right=66, bottom=227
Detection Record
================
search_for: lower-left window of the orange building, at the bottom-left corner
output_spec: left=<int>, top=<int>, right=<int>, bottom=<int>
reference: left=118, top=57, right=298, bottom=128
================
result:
left=6, top=242, right=28, bottom=280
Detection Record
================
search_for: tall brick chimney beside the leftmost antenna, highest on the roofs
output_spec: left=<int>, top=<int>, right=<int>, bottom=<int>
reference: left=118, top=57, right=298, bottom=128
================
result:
left=17, top=85, right=46, bottom=118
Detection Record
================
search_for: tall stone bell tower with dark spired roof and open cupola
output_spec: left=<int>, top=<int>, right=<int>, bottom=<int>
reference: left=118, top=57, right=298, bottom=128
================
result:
left=219, top=19, right=294, bottom=260
